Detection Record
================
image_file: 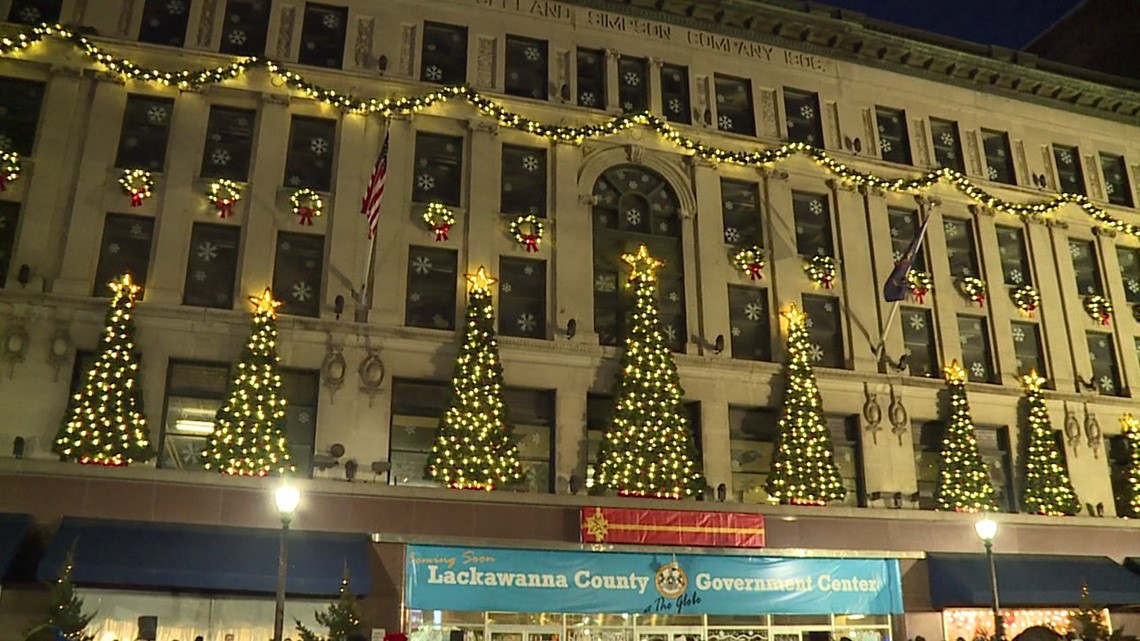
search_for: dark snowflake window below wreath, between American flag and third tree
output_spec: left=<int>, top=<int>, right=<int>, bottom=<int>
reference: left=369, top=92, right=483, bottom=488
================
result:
left=404, top=245, right=458, bottom=330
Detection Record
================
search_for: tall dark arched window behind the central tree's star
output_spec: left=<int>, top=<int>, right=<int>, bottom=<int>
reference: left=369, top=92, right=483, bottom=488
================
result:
left=593, top=164, right=685, bottom=351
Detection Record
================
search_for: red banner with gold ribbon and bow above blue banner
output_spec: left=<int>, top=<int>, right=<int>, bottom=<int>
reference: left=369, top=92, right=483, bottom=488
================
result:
left=581, top=508, right=764, bottom=547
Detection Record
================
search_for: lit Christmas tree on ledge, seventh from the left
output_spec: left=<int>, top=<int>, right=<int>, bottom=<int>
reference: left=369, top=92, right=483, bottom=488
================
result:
left=1021, top=370, right=1081, bottom=517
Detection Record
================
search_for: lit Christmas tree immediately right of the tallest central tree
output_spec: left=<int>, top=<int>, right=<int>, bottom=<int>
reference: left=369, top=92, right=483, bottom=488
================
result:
left=765, top=305, right=847, bottom=505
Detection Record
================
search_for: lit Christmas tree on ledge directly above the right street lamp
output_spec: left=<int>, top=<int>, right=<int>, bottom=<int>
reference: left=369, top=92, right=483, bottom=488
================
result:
left=938, top=360, right=998, bottom=512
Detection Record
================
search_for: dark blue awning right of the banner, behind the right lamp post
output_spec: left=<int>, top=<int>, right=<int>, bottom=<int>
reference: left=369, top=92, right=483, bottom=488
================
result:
left=927, top=553, right=1140, bottom=609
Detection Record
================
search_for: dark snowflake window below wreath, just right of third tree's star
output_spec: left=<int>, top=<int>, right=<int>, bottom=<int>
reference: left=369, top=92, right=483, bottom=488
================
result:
left=498, top=258, right=546, bottom=339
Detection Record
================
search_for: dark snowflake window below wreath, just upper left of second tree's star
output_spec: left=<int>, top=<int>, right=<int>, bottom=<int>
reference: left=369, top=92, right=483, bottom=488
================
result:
left=182, top=222, right=242, bottom=309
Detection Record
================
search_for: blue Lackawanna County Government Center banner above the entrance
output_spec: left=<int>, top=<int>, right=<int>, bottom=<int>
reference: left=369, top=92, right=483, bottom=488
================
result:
left=405, top=545, right=903, bottom=615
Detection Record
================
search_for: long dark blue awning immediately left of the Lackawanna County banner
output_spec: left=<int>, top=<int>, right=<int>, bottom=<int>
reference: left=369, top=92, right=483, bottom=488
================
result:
left=39, top=518, right=372, bottom=597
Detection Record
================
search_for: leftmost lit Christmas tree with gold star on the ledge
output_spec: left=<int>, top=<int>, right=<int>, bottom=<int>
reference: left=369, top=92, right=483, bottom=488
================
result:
left=51, top=274, right=154, bottom=465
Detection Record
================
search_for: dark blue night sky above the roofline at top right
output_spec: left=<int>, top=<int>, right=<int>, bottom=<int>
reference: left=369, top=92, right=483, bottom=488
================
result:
left=823, top=0, right=1081, bottom=49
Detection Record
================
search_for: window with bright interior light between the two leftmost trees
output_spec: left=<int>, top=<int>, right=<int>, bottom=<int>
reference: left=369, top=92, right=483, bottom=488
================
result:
left=158, top=360, right=229, bottom=470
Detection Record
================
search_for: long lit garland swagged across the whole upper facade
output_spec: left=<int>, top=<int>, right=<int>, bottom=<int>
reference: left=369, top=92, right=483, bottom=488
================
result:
left=0, top=24, right=1140, bottom=237
